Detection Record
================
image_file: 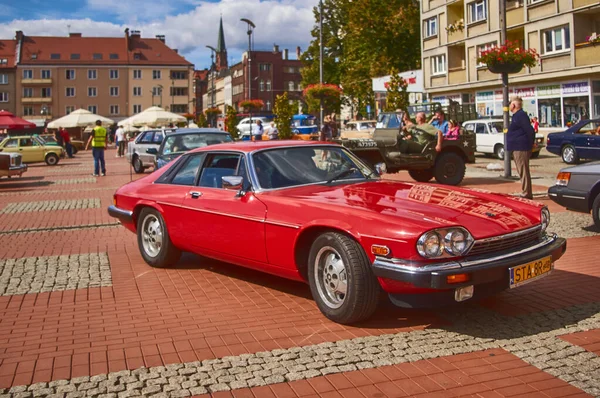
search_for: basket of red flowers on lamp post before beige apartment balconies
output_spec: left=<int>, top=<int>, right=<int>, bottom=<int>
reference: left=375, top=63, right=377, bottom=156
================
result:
left=477, top=41, right=540, bottom=73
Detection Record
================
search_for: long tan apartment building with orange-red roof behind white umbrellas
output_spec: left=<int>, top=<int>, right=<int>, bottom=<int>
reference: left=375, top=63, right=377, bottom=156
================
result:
left=15, top=29, right=194, bottom=121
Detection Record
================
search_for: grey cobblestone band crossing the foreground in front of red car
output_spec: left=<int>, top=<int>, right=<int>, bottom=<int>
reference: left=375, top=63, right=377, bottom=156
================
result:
left=0, top=303, right=600, bottom=397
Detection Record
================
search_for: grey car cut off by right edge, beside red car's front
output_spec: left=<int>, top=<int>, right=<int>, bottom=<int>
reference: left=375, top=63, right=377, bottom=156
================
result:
left=548, top=162, right=600, bottom=228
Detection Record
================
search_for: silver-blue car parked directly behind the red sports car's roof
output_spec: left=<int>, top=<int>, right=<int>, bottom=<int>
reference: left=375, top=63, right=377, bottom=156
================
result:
left=147, top=128, right=233, bottom=170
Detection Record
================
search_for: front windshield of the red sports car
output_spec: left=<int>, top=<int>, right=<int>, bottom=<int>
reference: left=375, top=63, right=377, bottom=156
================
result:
left=252, top=146, right=379, bottom=189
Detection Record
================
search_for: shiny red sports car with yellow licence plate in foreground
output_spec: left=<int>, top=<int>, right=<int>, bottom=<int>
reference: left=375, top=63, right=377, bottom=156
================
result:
left=108, top=141, right=566, bottom=323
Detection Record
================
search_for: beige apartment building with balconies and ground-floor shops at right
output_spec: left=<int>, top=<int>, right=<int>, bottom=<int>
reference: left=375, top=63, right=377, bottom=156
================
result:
left=420, top=0, right=600, bottom=128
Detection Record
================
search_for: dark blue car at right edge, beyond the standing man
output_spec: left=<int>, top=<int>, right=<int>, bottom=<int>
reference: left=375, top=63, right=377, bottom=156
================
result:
left=546, top=119, right=600, bottom=164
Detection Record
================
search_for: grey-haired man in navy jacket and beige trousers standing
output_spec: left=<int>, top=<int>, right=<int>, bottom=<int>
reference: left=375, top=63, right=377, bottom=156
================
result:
left=506, top=97, right=535, bottom=199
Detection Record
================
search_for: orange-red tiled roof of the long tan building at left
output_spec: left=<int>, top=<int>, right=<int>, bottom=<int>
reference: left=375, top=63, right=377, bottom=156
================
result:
left=21, top=33, right=192, bottom=66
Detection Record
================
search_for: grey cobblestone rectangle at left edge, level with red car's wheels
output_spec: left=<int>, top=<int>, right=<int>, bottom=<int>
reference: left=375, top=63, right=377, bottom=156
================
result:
left=0, top=253, right=112, bottom=296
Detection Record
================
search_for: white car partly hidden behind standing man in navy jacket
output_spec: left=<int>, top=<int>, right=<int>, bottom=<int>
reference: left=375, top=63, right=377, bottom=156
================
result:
left=462, top=119, right=544, bottom=159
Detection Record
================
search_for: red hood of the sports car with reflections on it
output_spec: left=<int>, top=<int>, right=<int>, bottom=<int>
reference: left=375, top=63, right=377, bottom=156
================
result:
left=259, top=180, right=541, bottom=239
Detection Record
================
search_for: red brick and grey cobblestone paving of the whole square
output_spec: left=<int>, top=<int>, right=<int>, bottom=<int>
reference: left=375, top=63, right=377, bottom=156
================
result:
left=0, top=152, right=600, bottom=398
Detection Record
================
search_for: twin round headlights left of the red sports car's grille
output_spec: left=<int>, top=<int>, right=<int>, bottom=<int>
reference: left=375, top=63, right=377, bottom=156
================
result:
left=417, top=227, right=474, bottom=258
